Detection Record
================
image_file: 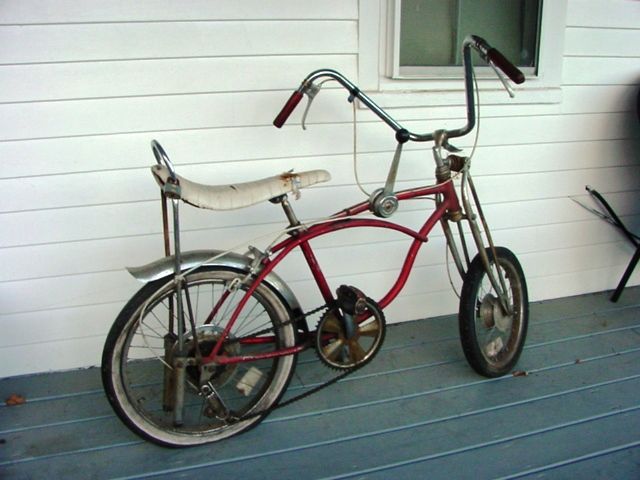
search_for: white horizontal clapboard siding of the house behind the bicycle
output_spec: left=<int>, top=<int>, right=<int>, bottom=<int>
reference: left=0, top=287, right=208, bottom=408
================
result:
left=0, top=0, right=640, bottom=377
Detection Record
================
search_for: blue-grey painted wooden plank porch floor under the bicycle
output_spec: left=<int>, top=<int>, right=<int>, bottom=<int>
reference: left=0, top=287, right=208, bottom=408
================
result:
left=0, top=287, right=640, bottom=479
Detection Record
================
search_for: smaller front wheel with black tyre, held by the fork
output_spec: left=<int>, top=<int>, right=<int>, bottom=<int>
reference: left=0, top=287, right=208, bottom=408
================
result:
left=458, top=247, right=529, bottom=377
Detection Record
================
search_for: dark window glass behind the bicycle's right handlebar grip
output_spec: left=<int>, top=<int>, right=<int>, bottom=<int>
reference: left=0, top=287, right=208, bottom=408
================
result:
left=391, top=0, right=541, bottom=78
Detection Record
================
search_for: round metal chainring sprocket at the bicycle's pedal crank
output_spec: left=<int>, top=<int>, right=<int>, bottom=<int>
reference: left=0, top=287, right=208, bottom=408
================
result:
left=316, top=298, right=386, bottom=370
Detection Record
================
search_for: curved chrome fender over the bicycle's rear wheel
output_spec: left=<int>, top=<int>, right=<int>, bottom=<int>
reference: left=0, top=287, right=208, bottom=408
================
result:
left=127, top=250, right=302, bottom=314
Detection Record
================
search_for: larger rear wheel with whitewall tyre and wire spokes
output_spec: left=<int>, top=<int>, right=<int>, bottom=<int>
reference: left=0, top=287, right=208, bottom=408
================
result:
left=102, top=267, right=295, bottom=446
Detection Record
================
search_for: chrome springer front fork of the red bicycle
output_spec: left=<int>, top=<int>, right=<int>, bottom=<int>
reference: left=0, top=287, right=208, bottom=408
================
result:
left=433, top=135, right=513, bottom=315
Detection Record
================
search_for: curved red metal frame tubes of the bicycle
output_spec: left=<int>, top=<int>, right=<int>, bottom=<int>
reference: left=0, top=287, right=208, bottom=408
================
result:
left=203, top=181, right=460, bottom=365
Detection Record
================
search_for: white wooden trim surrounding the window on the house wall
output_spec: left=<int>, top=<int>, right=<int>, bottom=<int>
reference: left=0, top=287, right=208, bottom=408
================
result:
left=358, top=0, right=568, bottom=108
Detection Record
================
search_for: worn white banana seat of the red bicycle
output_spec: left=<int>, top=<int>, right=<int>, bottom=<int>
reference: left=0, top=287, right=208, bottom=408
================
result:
left=151, top=165, right=331, bottom=210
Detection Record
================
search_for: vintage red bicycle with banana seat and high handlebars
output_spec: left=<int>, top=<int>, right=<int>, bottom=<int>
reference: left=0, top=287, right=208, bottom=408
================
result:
left=102, top=35, right=528, bottom=446
